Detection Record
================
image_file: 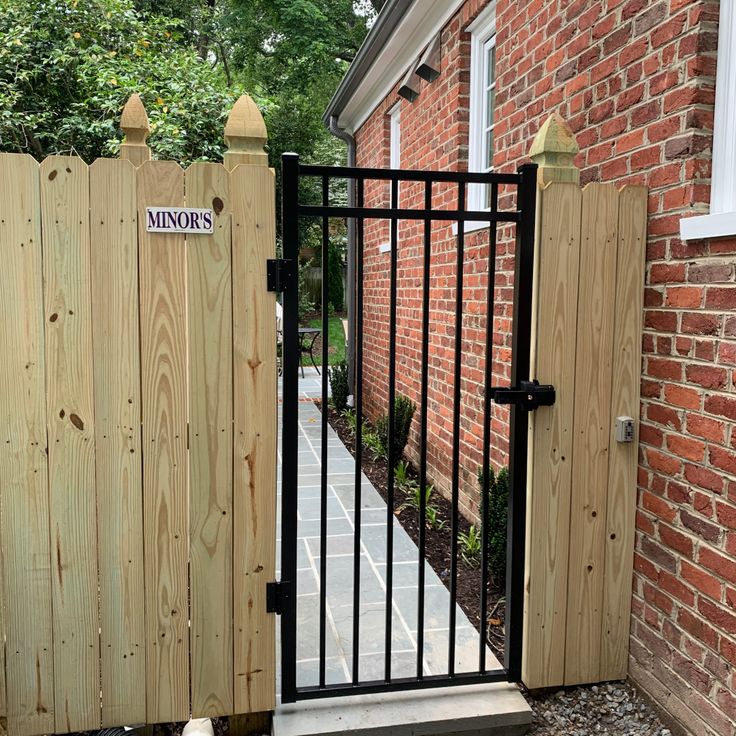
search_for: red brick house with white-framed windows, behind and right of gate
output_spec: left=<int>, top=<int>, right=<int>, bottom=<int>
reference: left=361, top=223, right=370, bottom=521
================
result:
left=325, top=0, right=736, bottom=735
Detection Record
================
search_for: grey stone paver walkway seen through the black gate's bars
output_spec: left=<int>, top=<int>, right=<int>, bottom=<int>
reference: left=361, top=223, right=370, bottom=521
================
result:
left=279, top=369, right=499, bottom=687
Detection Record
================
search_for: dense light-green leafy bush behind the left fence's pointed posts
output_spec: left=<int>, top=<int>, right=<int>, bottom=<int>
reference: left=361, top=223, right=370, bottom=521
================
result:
left=0, top=0, right=238, bottom=163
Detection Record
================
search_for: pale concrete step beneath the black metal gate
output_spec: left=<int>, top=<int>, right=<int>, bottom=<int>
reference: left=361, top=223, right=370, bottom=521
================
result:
left=272, top=683, right=532, bottom=736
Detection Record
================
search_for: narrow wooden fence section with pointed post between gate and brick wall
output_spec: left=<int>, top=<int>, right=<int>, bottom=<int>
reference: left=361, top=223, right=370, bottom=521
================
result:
left=523, top=116, right=647, bottom=688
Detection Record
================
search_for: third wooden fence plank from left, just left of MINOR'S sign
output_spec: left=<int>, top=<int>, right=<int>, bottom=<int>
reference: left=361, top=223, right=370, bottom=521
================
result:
left=90, top=159, right=146, bottom=727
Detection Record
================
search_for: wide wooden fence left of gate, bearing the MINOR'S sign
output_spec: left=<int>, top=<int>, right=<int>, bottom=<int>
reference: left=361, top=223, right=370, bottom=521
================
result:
left=0, top=97, right=277, bottom=735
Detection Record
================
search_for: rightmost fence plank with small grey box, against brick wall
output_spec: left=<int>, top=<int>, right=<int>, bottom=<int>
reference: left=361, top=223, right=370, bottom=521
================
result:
left=598, top=186, right=647, bottom=680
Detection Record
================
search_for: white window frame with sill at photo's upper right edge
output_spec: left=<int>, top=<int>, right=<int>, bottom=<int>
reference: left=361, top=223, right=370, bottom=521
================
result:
left=680, top=0, right=736, bottom=240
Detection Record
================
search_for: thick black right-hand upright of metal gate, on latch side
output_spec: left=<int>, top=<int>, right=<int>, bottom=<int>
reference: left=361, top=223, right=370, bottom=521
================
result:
left=504, top=164, right=537, bottom=682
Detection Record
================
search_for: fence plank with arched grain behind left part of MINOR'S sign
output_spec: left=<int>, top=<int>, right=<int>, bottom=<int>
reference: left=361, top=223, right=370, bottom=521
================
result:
left=137, top=161, right=189, bottom=723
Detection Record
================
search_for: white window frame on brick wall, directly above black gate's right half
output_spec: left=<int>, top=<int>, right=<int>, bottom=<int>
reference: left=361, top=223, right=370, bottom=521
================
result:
left=465, top=2, right=496, bottom=231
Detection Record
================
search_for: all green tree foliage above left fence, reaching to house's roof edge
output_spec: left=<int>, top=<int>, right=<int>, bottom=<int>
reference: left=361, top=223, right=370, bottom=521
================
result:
left=0, top=0, right=384, bottom=167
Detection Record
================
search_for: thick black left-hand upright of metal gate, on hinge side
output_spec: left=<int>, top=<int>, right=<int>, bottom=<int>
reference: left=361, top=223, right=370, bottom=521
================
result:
left=281, top=153, right=299, bottom=703
